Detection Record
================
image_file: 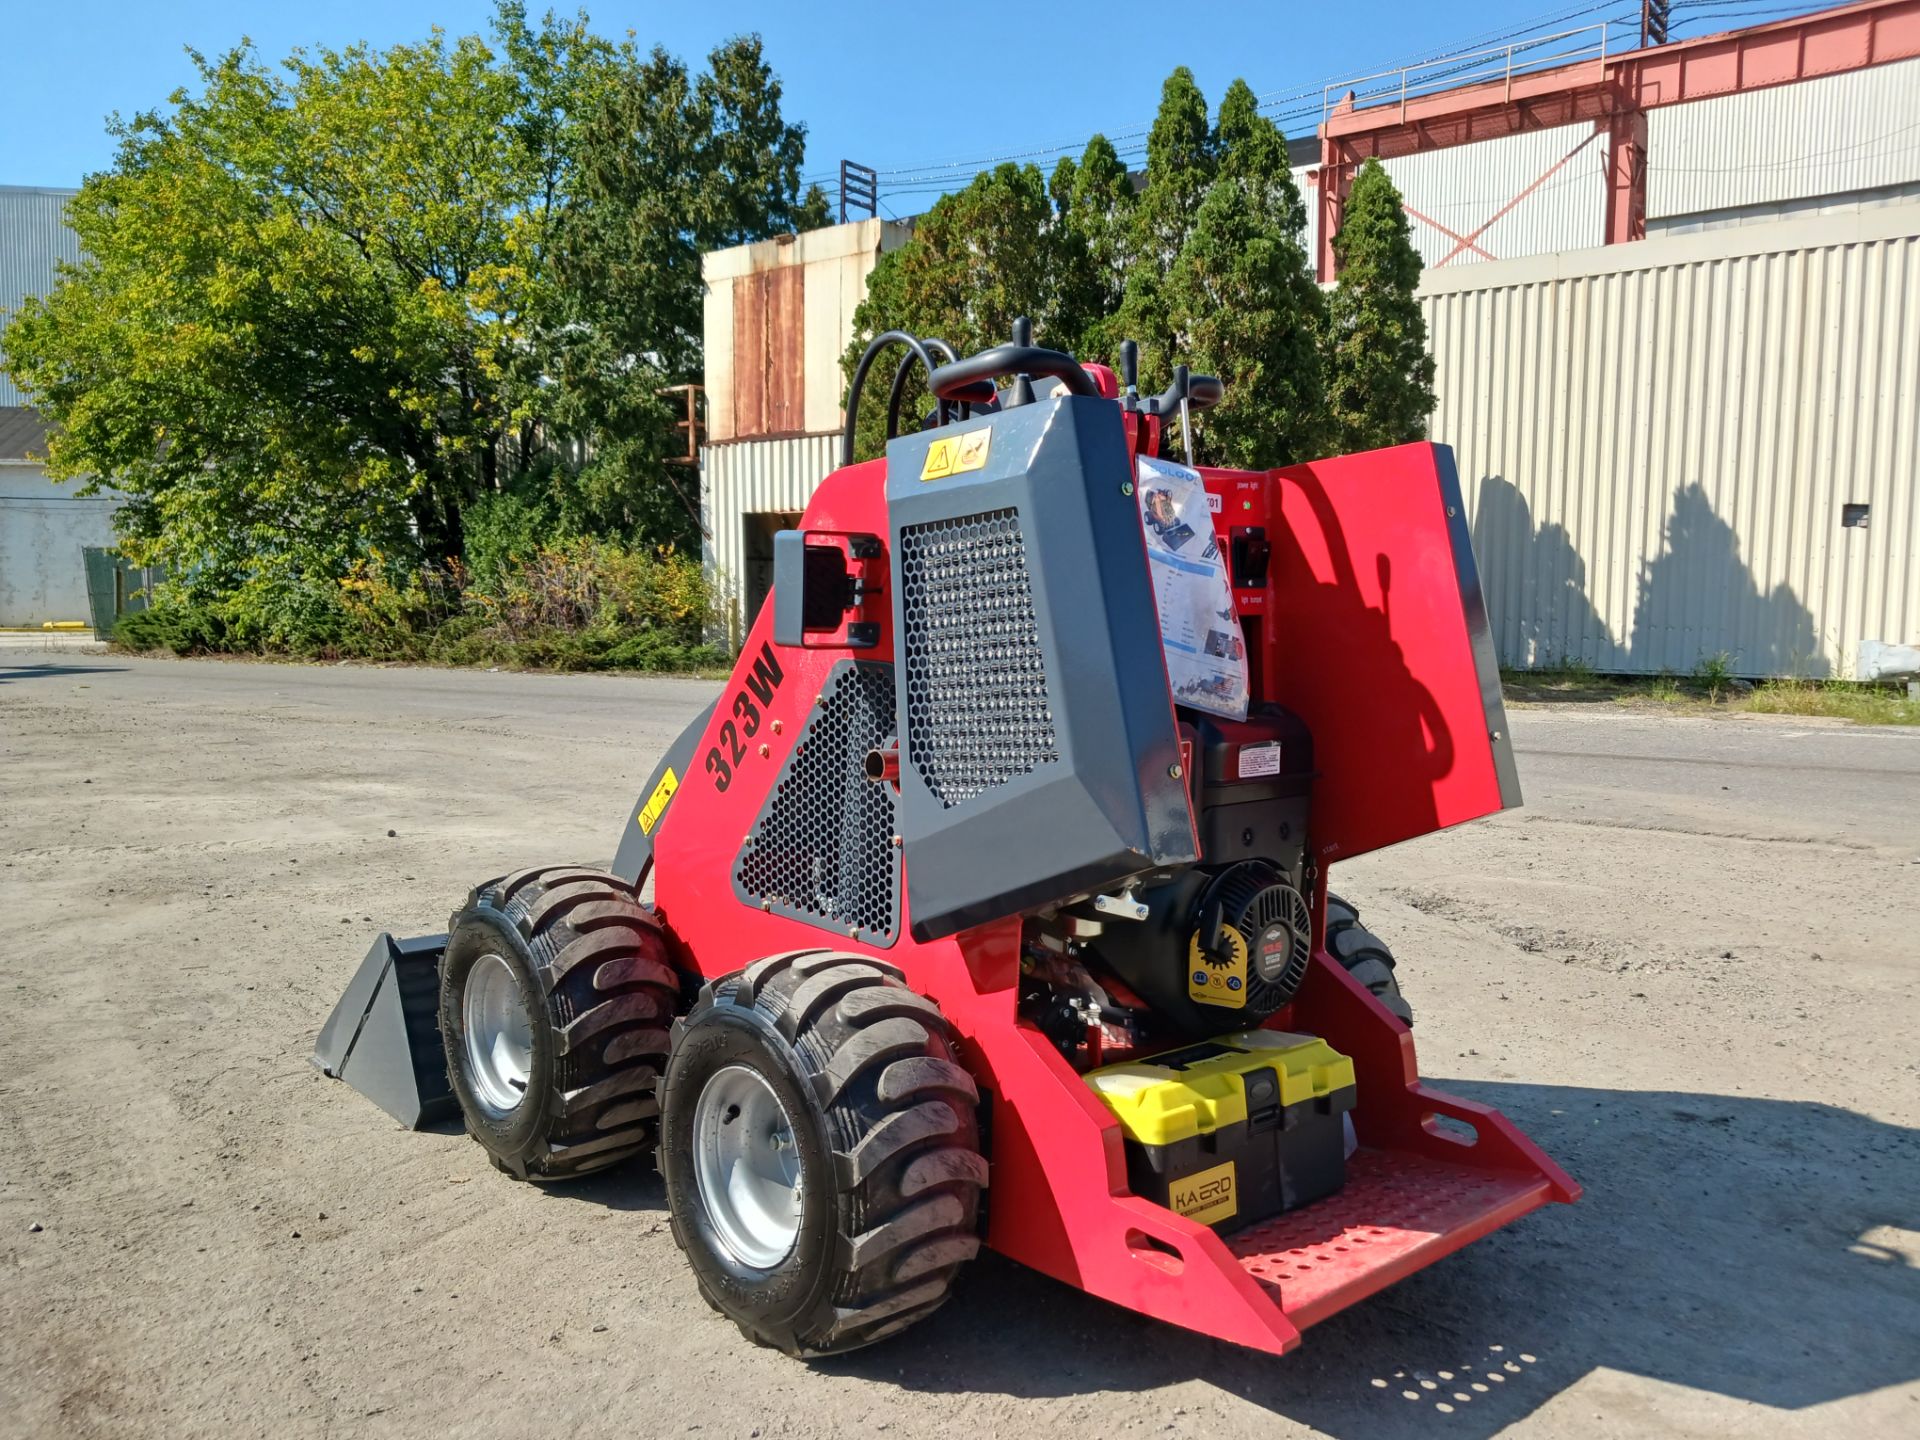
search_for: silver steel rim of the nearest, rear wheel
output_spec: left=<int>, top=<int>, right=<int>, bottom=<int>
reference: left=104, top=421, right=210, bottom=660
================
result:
left=693, top=1066, right=803, bottom=1269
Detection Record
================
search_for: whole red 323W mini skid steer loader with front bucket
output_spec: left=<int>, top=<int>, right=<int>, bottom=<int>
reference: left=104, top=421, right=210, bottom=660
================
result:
left=315, top=326, right=1578, bottom=1356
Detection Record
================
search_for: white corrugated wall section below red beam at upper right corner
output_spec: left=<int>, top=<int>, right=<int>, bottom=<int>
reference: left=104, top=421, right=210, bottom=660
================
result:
left=1647, top=60, right=1920, bottom=228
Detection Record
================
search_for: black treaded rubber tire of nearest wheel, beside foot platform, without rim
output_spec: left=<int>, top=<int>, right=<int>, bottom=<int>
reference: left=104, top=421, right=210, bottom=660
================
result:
left=659, top=950, right=987, bottom=1357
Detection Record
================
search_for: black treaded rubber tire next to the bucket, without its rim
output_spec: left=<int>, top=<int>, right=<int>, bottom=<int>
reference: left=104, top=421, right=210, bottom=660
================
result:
left=440, top=866, right=680, bottom=1181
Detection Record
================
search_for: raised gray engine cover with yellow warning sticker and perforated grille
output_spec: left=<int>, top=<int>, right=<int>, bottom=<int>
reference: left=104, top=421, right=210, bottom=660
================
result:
left=887, top=396, right=1196, bottom=941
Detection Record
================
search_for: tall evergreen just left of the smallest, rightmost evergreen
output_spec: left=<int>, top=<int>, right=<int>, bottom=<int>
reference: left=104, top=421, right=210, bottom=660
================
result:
left=1165, top=81, right=1323, bottom=467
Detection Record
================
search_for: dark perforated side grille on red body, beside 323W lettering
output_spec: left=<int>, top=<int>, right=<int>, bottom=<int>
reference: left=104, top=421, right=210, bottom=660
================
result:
left=733, top=662, right=900, bottom=945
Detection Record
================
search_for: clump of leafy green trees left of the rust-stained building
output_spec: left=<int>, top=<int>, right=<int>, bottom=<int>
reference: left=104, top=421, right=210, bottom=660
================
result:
left=6, top=4, right=824, bottom=628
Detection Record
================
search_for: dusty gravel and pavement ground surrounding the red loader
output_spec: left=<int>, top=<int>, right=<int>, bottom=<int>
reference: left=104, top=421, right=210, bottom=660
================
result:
left=0, top=655, right=1920, bottom=1440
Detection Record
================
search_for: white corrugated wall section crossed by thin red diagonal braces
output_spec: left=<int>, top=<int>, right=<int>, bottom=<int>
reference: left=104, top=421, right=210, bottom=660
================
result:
left=1386, top=125, right=1607, bottom=269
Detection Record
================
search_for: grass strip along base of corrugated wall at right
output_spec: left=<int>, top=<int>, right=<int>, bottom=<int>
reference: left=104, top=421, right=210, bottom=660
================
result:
left=1500, top=668, right=1920, bottom=726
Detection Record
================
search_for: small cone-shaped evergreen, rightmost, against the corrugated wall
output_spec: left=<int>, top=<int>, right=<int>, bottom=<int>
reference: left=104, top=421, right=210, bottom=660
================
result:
left=1327, top=159, right=1434, bottom=449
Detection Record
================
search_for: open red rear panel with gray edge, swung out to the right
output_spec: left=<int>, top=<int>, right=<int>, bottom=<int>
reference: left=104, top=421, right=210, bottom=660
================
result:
left=1208, top=444, right=1521, bottom=862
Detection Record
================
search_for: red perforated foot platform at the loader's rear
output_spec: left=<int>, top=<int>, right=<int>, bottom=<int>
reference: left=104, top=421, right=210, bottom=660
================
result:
left=1223, top=1150, right=1553, bottom=1329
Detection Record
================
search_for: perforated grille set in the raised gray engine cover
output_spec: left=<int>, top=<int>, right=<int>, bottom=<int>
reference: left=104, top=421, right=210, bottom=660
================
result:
left=900, top=509, right=1060, bottom=808
